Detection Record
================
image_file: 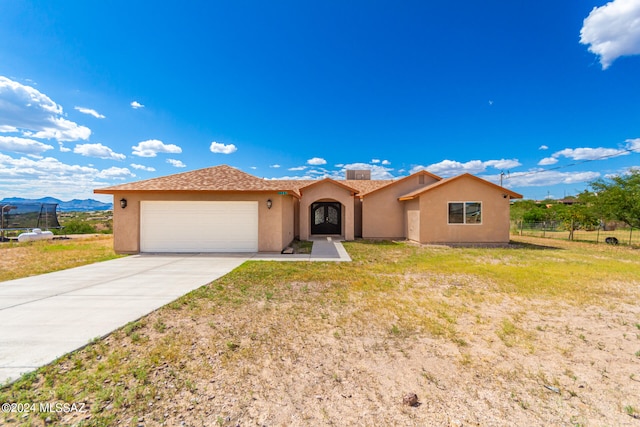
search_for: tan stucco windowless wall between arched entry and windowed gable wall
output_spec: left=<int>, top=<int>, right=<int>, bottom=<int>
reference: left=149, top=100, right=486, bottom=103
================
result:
left=362, top=175, right=436, bottom=239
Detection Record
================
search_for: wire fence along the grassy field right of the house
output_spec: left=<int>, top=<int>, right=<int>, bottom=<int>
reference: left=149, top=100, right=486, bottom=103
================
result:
left=511, top=221, right=640, bottom=246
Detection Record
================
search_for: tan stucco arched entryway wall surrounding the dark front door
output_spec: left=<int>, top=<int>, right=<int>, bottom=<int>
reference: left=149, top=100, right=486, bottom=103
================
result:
left=300, top=182, right=355, bottom=240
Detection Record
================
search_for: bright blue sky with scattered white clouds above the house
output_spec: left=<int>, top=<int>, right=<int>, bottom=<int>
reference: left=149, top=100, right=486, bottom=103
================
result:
left=0, top=0, right=640, bottom=200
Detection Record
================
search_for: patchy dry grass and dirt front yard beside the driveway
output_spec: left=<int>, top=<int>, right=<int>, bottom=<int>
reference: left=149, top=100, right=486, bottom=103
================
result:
left=0, top=239, right=640, bottom=426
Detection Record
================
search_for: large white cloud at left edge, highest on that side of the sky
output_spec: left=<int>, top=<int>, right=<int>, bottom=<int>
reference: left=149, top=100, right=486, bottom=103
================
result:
left=0, top=76, right=91, bottom=141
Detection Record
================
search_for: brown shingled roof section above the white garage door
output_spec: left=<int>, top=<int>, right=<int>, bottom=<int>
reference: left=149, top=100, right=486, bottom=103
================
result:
left=94, top=165, right=300, bottom=197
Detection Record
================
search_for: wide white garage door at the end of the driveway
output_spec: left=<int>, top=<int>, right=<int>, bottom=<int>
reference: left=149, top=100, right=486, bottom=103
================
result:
left=140, top=201, right=258, bottom=252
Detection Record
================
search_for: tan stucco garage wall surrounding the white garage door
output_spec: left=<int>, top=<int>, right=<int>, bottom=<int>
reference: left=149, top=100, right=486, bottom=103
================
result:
left=113, top=192, right=295, bottom=253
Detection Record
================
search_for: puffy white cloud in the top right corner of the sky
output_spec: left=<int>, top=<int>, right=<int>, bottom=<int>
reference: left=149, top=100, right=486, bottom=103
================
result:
left=580, top=0, right=640, bottom=70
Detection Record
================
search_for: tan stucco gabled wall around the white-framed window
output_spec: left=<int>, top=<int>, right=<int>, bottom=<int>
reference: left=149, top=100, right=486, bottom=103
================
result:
left=420, top=177, right=509, bottom=243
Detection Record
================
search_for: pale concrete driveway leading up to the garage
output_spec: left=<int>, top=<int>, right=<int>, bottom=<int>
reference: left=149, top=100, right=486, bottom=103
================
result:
left=0, top=254, right=253, bottom=384
